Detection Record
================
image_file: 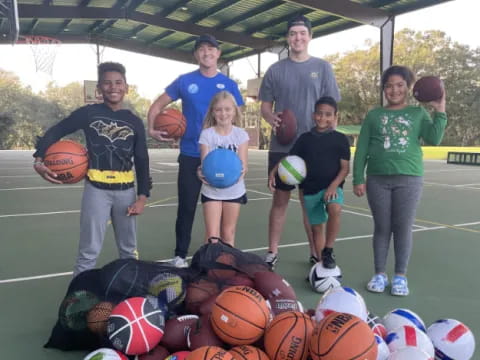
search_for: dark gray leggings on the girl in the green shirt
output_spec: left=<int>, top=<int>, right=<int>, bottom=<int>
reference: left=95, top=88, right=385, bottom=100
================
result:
left=367, top=175, right=423, bottom=274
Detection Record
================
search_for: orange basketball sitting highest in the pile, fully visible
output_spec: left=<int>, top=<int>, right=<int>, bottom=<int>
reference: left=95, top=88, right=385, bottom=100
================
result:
left=210, top=286, right=270, bottom=345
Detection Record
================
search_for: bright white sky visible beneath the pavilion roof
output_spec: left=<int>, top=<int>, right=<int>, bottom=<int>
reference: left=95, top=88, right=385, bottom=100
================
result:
left=0, top=0, right=480, bottom=100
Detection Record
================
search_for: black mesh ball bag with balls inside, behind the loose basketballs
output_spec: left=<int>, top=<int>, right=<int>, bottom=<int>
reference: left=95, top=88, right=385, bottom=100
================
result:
left=45, top=241, right=269, bottom=351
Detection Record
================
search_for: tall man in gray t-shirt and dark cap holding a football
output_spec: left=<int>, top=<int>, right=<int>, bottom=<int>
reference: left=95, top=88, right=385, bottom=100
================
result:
left=259, top=15, right=340, bottom=268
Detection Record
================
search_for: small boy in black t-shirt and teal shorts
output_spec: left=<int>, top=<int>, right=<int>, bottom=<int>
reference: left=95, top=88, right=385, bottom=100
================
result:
left=269, top=96, right=350, bottom=269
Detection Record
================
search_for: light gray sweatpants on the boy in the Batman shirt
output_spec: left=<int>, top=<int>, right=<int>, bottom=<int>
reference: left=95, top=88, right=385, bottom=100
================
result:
left=73, top=181, right=137, bottom=276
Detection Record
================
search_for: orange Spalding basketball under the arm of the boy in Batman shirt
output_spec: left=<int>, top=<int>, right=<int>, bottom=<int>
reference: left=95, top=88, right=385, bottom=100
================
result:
left=43, top=140, right=88, bottom=184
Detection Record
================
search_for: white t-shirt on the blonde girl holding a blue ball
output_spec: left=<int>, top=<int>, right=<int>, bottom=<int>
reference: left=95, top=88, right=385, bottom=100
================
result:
left=198, top=126, right=249, bottom=200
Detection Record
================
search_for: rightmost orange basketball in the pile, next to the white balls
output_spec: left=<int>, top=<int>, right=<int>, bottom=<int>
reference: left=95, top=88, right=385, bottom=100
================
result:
left=310, top=312, right=377, bottom=360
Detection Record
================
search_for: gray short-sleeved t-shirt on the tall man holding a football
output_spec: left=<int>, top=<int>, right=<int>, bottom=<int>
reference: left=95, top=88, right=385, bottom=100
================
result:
left=259, top=57, right=340, bottom=152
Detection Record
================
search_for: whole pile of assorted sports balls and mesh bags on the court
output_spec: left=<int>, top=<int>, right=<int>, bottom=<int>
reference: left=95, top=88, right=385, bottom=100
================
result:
left=47, top=243, right=475, bottom=360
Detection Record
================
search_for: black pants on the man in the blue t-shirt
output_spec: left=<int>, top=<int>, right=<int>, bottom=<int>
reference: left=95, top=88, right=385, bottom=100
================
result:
left=175, top=154, right=202, bottom=258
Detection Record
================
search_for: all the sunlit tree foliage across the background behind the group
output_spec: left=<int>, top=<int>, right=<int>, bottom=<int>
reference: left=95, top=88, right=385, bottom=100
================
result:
left=0, top=30, right=480, bottom=149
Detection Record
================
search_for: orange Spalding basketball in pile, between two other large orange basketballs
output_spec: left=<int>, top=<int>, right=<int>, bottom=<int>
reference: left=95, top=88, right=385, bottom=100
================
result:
left=263, top=311, right=314, bottom=360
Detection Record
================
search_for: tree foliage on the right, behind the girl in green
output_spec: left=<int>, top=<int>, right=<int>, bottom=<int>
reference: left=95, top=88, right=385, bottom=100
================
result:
left=328, top=29, right=480, bottom=146
